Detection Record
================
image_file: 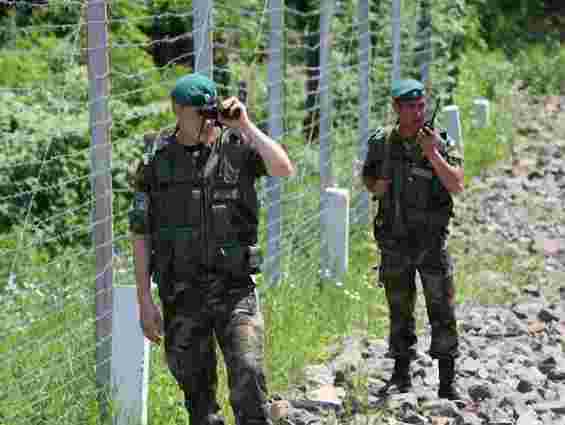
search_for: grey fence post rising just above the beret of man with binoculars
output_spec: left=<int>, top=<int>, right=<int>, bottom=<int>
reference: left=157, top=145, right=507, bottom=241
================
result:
left=192, top=0, right=214, bottom=78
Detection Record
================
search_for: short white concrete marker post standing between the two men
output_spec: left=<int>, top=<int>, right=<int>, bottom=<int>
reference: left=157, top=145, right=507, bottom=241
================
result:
left=325, top=187, right=349, bottom=279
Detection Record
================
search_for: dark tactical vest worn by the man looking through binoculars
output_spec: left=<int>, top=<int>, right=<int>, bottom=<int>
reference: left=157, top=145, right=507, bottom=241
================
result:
left=146, top=138, right=259, bottom=282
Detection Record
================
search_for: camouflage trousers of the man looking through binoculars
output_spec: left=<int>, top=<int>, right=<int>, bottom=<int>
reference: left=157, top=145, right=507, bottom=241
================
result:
left=163, top=277, right=271, bottom=425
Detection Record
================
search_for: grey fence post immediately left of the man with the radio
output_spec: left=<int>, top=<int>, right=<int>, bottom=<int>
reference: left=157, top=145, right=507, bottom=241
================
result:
left=355, top=0, right=371, bottom=224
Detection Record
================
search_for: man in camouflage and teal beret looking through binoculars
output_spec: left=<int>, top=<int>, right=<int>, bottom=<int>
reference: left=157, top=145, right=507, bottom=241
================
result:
left=130, top=74, right=293, bottom=425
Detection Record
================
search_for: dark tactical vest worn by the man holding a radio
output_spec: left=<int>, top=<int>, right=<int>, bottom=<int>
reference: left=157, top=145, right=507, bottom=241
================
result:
left=375, top=128, right=453, bottom=237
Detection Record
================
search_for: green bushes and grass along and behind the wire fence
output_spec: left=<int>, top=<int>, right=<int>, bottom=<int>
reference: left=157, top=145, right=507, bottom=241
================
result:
left=0, top=0, right=565, bottom=425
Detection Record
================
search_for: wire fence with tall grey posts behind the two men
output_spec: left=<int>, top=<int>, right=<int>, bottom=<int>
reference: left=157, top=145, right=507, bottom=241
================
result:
left=0, top=0, right=476, bottom=425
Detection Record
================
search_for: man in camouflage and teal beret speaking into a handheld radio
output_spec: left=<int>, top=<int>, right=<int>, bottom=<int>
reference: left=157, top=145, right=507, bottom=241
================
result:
left=363, top=80, right=463, bottom=400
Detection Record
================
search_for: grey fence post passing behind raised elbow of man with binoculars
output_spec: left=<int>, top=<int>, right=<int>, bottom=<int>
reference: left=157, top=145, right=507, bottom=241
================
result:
left=266, top=0, right=284, bottom=285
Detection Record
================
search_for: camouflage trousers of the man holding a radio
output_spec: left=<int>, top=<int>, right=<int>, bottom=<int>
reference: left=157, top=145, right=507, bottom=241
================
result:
left=379, top=236, right=458, bottom=358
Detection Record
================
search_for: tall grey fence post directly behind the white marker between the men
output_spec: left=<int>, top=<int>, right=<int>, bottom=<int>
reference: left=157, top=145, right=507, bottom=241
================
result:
left=319, top=0, right=335, bottom=276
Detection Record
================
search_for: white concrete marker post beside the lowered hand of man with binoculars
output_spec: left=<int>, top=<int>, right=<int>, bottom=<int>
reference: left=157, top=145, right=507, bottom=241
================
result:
left=111, top=286, right=150, bottom=425
